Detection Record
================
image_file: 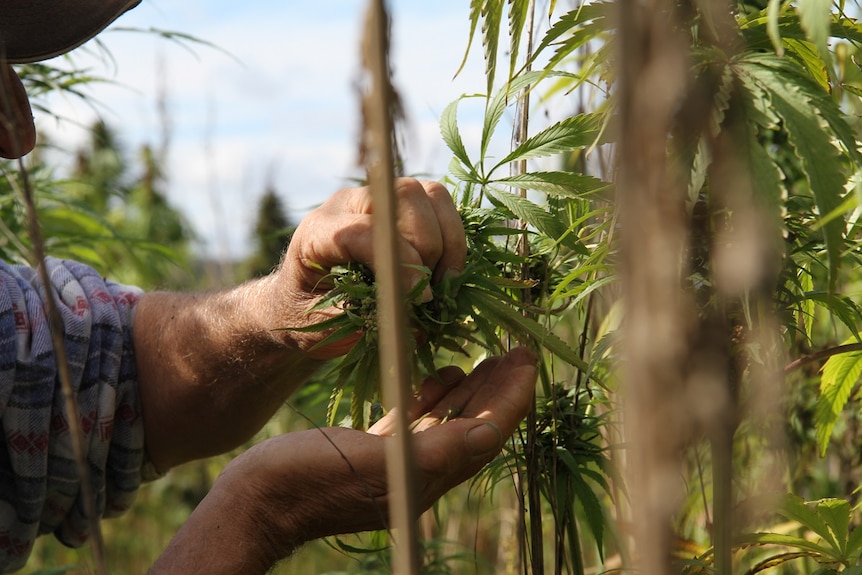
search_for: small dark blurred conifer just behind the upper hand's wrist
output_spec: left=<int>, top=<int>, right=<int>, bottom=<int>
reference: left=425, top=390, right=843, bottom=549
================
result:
left=247, top=185, right=296, bottom=277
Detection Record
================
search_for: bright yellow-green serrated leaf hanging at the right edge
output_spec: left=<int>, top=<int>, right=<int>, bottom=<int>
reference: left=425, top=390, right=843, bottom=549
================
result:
left=814, top=340, right=862, bottom=455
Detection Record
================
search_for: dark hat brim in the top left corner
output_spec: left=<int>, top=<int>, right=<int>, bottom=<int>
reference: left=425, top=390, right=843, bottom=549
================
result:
left=0, top=0, right=141, bottom=63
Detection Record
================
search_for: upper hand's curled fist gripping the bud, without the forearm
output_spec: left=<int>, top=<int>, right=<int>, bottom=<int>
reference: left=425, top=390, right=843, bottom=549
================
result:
left=275, top=178, right=467, bottom=359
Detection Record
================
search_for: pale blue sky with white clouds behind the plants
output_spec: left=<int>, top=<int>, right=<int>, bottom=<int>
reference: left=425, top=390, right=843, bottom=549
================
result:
left=37, top=0, right=500, bottom=257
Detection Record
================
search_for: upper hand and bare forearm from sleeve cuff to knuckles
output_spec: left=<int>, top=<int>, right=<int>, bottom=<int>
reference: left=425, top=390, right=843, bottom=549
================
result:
left=134, top=179, right=467, bottom=471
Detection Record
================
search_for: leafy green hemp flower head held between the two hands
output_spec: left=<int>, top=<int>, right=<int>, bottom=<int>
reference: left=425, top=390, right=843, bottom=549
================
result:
left=288, top=192, right=586, bottom=428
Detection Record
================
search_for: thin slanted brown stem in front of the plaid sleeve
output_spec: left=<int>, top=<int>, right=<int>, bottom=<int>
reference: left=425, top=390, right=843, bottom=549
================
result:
left=0, top=63, right=108, bottom=575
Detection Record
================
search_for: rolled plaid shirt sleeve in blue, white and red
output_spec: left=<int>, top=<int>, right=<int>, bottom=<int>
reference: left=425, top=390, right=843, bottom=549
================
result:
left=0, top=259, right=151, bottom=573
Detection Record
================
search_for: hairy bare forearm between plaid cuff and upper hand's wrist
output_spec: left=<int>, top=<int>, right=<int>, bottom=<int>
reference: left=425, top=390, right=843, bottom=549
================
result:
left=134, top=277, right=320, bottom=470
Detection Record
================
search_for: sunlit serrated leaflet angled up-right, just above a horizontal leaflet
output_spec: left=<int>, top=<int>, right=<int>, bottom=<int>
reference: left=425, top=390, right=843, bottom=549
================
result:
left=489, top=114, right=602, bottom=174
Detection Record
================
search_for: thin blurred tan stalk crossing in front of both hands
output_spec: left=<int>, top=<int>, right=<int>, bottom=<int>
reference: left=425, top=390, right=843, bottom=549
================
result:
left=362, top=0, right=419, bottom=575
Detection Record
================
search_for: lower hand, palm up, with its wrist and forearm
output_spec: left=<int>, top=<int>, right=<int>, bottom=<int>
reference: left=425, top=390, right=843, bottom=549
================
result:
left=151, top=348, right=536, bottom=575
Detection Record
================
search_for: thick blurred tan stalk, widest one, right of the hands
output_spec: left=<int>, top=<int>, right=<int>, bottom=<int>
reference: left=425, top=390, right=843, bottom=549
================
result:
left=617, top=0, right=696, bottom=575
